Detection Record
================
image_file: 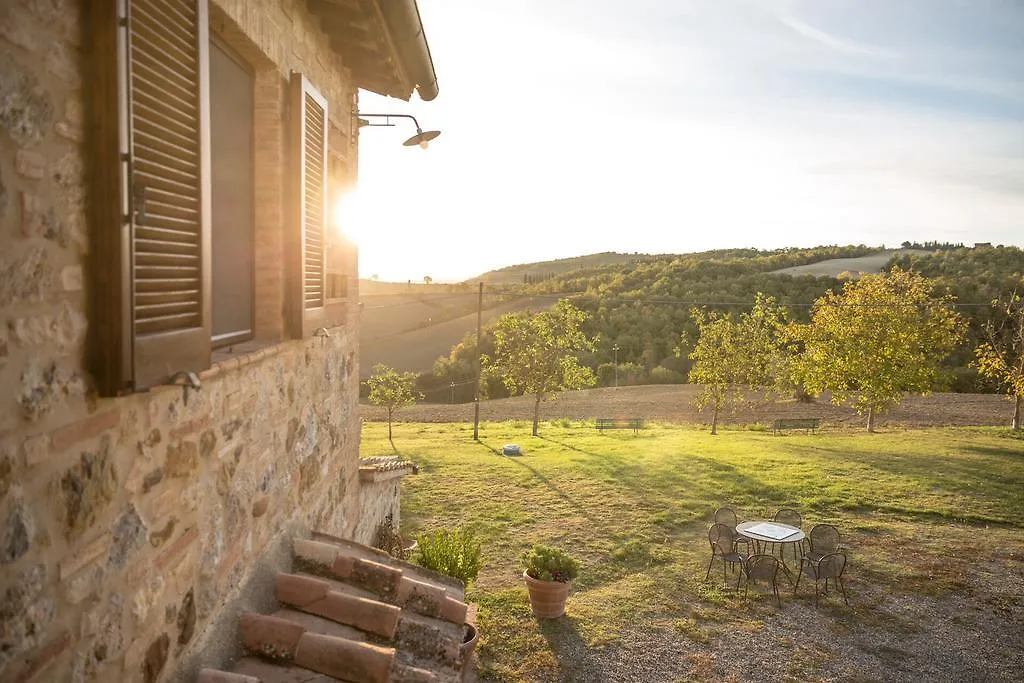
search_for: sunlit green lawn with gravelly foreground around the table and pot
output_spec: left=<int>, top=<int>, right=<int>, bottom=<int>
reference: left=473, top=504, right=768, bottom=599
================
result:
left=361, top=420, right=1024, bottom=681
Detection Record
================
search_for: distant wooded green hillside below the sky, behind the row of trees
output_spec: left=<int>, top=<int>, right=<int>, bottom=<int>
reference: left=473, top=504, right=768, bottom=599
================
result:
left=507, top=245, right=1024, bottom=391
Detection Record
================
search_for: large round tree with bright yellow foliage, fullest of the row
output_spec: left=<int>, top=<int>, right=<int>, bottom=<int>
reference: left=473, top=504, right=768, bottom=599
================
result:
left=792, top=267, right=965, bottom=432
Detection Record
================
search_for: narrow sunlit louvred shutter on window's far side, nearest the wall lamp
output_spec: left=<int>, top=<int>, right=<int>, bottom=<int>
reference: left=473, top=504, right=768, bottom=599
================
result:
left=292, top=73, right=328, bottom=337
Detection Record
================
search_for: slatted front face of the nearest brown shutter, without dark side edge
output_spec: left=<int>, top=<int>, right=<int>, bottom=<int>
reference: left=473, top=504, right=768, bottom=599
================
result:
left=128, top=0, right=211, bottom=387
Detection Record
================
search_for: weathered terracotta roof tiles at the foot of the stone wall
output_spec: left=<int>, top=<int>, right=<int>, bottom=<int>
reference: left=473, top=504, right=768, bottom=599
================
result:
left=198, top=533, right=474, bottom=683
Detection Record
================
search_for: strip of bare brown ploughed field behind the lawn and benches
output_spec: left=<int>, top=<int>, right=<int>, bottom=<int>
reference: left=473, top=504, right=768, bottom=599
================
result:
left=360, top=384, right=1013, bottom=429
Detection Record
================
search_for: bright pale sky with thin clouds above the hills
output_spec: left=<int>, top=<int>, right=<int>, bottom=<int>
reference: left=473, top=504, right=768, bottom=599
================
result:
left=344, top=0, right=1024, bottom=282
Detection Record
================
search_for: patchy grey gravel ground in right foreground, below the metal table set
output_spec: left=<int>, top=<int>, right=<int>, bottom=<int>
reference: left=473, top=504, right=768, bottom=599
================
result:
left=503, top=566, right=1024, bottom=683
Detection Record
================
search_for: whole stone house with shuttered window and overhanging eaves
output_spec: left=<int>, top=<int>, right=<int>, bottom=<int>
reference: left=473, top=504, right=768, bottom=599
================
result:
left=0, top=0, right=448, bottom=683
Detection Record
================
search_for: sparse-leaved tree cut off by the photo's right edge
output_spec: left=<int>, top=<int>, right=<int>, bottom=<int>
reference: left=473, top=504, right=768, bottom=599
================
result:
left=975, top=292, right=1024, bottom=431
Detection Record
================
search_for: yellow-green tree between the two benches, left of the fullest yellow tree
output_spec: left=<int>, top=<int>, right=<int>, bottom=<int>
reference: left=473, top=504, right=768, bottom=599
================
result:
left=682, top=293, right=786, bottom=434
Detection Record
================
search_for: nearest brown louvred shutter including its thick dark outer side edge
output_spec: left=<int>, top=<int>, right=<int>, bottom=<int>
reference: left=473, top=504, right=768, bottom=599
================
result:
left=84, top=0, right=210, bottom=395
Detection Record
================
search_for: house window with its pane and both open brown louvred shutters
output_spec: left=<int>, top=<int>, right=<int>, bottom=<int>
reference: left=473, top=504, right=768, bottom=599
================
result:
left=86, top=0, right=335, bottom=395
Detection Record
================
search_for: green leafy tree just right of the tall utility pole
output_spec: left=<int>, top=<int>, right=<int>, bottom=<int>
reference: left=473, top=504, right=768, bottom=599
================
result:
left=481, top=299, right=597, bottom=436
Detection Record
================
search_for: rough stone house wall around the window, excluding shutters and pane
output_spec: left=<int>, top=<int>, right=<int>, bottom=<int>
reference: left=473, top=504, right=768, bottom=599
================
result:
left=0, top=0, right=374, bottom=683
